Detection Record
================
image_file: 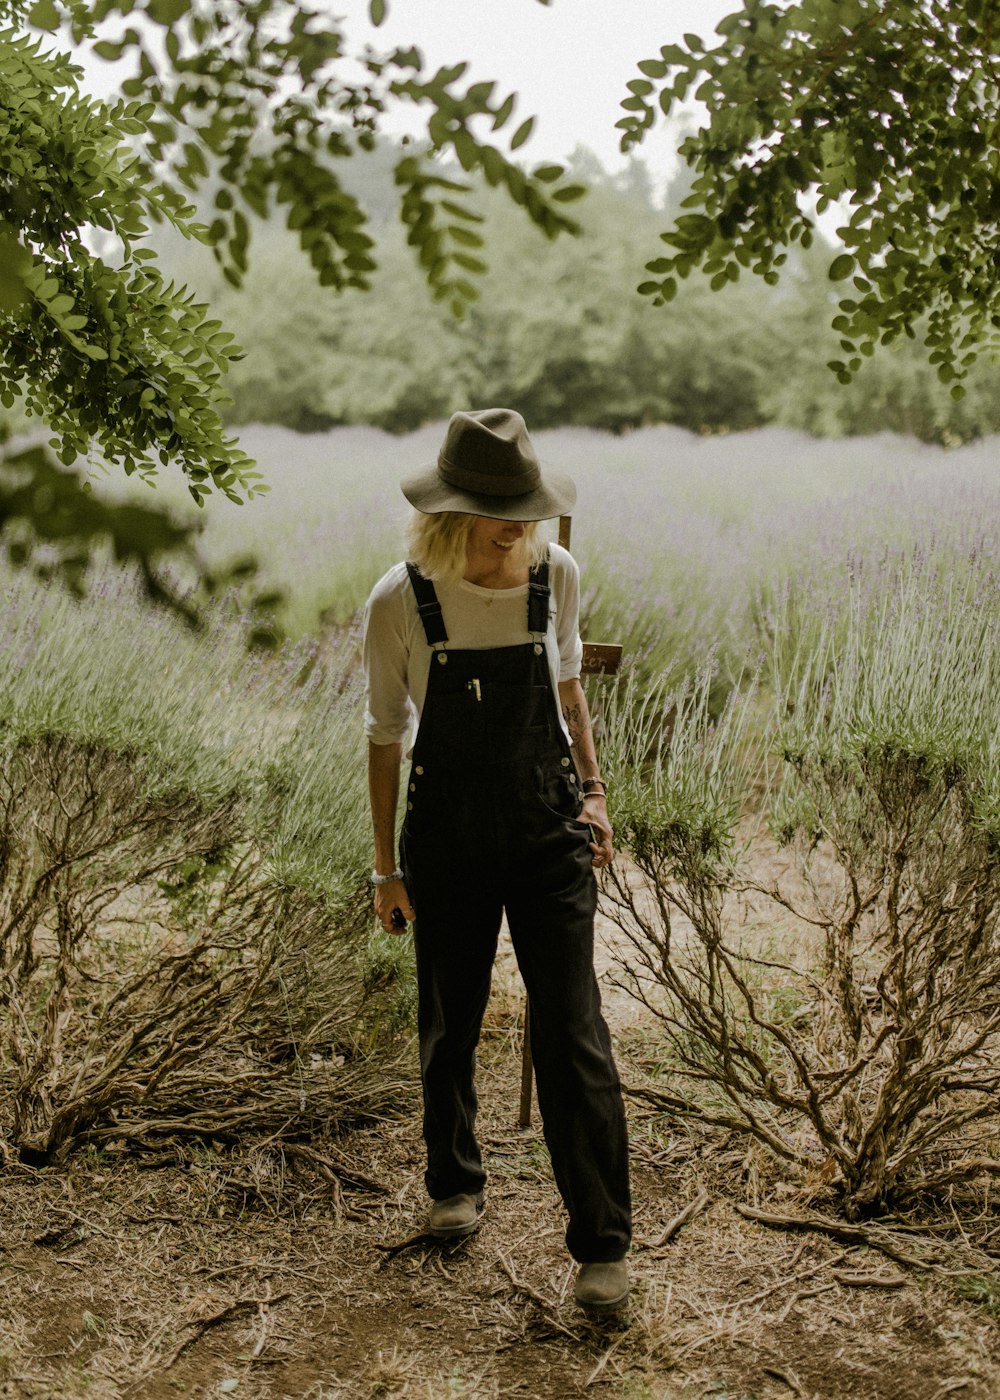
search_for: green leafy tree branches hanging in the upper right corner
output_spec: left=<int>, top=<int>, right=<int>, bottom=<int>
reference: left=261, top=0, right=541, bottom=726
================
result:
left=618, top=0, right=1000, bottom=398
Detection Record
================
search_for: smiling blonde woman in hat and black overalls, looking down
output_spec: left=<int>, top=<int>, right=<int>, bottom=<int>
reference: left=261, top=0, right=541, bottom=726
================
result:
left=364, top=409, right=630, bottom=1309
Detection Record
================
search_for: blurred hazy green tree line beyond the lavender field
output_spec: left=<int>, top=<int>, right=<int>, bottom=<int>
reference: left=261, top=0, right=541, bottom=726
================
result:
left=165, top=147, right=1000, bottom=442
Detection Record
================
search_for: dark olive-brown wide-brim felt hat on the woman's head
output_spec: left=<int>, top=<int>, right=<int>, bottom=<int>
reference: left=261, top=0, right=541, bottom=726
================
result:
left=399, top=409, right=577, bottom=521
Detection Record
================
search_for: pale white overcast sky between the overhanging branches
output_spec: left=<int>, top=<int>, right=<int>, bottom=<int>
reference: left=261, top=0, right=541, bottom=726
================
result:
left=338, top=0, right=739, bottom=182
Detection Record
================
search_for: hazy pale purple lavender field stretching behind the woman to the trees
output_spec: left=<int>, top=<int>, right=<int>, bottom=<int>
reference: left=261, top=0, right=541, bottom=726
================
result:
left=91, top=424, right=1000, bottom=660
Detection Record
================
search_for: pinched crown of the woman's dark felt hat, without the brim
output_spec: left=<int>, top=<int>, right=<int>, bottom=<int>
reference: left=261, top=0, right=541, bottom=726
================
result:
left=437, top=409, right=542, bottom=496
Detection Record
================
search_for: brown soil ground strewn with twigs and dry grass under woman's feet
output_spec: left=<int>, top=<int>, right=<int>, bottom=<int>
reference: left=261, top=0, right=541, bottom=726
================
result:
left=0, top=901, right=1000, bottom=1400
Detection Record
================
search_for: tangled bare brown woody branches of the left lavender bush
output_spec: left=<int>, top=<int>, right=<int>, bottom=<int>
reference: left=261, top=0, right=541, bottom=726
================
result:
left=0, top=738, right=409, bottom=1164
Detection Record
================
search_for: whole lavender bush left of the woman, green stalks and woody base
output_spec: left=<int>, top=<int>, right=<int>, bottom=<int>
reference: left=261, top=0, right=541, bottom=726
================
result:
left=0, top=560, right=409, bottom=1161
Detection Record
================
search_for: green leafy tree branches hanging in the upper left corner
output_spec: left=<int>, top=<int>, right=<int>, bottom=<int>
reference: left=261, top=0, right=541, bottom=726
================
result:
left=0, top=0, right=584, bottom=618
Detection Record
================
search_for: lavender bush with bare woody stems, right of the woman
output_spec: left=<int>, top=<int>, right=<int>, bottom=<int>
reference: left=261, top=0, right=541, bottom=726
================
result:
left=605, top=549, right=1000, bottom=1218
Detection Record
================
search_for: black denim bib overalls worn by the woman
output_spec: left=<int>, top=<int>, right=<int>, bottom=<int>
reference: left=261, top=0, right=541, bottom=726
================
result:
left=401, top=561, right=630, bottom=1263
